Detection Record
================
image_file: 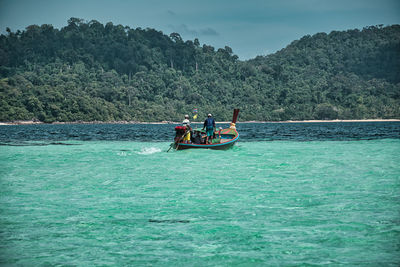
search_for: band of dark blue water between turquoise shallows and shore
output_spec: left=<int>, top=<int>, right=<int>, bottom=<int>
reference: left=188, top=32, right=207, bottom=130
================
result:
left=0, top=122, right=400, bottom=145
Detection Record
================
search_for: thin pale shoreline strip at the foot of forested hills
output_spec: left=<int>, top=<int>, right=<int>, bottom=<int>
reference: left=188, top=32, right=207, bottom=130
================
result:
left=0, top=119, right=400, bottom=126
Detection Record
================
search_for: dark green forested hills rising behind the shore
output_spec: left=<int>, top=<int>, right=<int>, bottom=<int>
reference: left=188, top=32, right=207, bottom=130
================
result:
left=0, top=18, right=400, bottom=122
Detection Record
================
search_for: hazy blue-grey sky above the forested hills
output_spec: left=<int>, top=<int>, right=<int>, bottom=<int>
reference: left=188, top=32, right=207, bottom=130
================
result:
left=0, top=0, right=400, bottom=60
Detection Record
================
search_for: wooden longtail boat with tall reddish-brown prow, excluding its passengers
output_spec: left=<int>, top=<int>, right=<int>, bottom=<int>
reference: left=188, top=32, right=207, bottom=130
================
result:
left=171, top=109, right=239, bottom=150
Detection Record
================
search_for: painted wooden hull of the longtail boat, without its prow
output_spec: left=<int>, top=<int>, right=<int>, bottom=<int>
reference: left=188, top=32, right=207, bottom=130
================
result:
left=174, top=128, right=239, bottom=150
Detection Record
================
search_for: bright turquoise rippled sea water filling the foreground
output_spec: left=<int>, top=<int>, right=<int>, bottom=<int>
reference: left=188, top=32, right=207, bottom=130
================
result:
left=0, top=126, right=400, bottom=266
